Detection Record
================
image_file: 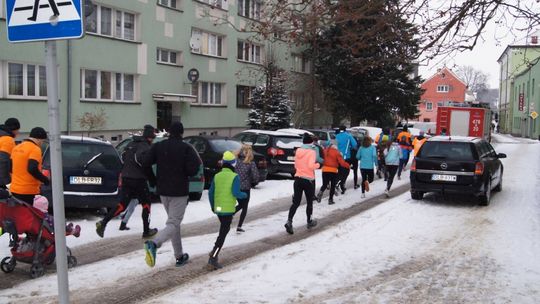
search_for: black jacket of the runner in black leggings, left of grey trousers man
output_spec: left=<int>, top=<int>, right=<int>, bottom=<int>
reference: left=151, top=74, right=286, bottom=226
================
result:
left=122, top=136, right=150, bottom=179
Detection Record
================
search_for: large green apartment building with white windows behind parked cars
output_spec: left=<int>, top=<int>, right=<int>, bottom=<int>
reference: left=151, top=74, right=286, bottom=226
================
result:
left=0, top=0, right=331, bottom=142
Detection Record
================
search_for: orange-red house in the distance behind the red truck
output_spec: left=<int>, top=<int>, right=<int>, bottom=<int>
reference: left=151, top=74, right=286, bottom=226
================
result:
left=418, top=67, right=467, bottom=122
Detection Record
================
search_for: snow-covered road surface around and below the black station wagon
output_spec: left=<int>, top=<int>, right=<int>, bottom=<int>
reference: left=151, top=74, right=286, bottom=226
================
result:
left=143, top=136, right=540, bottom=303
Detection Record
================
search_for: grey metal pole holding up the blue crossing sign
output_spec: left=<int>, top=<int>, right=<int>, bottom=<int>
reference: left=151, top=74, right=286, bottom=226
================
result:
left=45, top=40, right=69, bottom=304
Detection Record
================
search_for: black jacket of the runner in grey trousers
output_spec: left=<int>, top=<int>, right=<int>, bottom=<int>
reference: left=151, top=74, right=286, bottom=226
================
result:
left=143, top=137, right=201, bottom=196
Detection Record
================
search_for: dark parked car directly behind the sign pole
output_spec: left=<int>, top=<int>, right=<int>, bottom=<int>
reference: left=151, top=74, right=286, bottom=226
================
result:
left=41, top=136, right=122, bottom=209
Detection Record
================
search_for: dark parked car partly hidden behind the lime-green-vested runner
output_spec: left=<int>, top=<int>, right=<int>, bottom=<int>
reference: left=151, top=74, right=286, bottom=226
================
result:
left=184, top=135, right=268, bottom=188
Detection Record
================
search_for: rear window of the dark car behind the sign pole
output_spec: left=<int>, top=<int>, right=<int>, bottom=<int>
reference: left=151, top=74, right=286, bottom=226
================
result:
left=43, top=142, right=122, bottom=171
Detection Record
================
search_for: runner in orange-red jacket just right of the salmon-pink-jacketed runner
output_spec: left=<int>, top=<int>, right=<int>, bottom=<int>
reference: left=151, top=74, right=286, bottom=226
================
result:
left=317, top=140, right=350, bottom=205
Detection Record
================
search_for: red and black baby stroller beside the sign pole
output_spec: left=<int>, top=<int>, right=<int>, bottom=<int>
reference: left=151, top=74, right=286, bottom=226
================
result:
left=0, top=189, right=77, bottom=279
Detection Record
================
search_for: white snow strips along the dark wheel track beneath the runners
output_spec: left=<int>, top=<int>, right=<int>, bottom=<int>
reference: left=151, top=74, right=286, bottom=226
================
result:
left=0, top=164, right=408, bottom=302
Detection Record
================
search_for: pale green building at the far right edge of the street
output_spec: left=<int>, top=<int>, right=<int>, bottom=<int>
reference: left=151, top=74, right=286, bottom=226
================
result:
left=497, top=32, right=540, bottom=138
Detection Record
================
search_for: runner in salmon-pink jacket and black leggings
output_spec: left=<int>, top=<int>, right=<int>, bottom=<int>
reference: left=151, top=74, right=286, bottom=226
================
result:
left=285, top=133, right=320, bottom=234
